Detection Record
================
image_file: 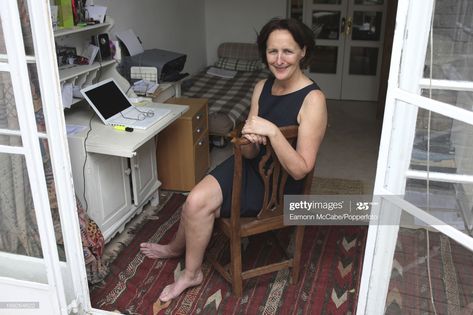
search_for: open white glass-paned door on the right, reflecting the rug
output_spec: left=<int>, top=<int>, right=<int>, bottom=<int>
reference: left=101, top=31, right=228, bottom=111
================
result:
left=357, top=0, right=473, bottom=314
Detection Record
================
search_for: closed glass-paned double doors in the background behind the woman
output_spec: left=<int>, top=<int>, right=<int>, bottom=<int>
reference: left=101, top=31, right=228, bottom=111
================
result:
left=303, top=0, right=387, bottom=101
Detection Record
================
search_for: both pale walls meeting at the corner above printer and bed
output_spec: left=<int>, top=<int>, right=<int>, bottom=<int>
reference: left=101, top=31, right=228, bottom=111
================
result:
left=88, top=0, right=287, bottom=74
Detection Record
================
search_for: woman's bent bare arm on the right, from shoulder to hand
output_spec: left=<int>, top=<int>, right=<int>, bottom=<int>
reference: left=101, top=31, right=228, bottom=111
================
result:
left=242, top=91, right=327, bottom=179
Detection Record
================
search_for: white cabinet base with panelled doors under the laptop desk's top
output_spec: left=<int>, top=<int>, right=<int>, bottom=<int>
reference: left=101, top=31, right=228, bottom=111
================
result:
left=69, top=131, right=160, bottom=241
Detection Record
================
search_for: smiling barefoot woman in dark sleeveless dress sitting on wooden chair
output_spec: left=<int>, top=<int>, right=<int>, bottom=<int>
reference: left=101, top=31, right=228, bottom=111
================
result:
left=141, top=18, right=327, bottom=302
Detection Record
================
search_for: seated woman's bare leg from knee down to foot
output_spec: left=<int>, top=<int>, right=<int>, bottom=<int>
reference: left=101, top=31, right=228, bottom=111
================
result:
left=142, top=175, right=223, bottom=302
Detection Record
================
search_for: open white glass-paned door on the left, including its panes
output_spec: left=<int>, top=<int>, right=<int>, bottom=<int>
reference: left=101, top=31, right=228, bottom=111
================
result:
left=0, top=0, right=91, bottom=314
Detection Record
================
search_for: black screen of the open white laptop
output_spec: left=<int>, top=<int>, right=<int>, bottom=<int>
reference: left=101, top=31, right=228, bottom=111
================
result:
left=83, top=80, right=131, bottom=119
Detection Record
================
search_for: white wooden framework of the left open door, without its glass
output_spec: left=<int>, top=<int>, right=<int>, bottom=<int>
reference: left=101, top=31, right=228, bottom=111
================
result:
left=0, top=0, right=95, bottom=314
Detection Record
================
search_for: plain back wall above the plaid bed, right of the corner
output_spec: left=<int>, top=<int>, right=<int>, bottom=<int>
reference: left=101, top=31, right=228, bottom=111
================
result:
left=205, top=0, right=287, bottom=64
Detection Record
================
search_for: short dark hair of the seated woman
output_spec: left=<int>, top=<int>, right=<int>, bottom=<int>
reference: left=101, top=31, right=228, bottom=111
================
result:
left=256, top=18, right=315, bottom=69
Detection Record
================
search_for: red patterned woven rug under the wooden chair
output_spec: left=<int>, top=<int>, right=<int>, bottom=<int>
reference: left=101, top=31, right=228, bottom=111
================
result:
left=91, top=194, right=367, bottom=315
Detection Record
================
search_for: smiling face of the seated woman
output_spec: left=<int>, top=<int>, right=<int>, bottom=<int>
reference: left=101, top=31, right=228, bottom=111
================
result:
left=266, top=30, right=305, bottom=81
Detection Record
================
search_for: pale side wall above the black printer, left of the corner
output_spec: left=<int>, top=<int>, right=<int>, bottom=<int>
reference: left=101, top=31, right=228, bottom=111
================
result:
left=88, top=0, right=206, bottom=73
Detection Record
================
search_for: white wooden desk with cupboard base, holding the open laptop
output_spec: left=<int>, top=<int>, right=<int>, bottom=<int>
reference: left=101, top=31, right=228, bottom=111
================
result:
left=66, top=102, right=189, bottom=241
